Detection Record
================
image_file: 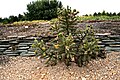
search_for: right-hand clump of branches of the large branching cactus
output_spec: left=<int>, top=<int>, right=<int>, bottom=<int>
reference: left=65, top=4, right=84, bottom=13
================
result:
left=75, top=26, right=99, bottom=66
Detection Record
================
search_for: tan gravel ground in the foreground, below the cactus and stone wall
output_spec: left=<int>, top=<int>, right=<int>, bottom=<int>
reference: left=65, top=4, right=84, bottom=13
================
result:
left=0, top=52, right=120, bottom=80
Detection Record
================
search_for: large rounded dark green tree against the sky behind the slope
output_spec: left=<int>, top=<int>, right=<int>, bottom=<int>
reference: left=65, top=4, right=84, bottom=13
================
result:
left=25, top=0, right=62, bottom=20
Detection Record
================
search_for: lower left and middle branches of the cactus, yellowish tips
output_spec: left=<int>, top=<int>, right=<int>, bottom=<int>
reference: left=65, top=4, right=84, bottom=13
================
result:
left=32, top=33, right=75, bottom=66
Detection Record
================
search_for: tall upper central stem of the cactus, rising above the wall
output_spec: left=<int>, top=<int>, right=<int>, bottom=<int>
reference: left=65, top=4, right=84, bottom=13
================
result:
left=58, top=6, right=79, bottom=35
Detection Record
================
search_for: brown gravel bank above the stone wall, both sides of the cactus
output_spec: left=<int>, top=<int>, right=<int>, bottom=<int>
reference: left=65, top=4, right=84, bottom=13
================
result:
left=0, top=22, right=120, bottom=39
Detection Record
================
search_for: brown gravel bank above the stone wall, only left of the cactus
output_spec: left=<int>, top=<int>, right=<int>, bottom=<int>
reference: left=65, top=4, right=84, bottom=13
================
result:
left=0, top=23, right=50, bottom=39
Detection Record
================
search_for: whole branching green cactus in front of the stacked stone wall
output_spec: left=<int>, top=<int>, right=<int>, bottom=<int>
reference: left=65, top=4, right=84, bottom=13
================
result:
left=32, top=6, right=105, bottom=66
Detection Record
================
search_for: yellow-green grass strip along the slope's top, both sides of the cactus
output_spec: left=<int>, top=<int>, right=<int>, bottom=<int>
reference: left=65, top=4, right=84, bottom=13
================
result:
left=0, top=16, right=120, bottom=26
